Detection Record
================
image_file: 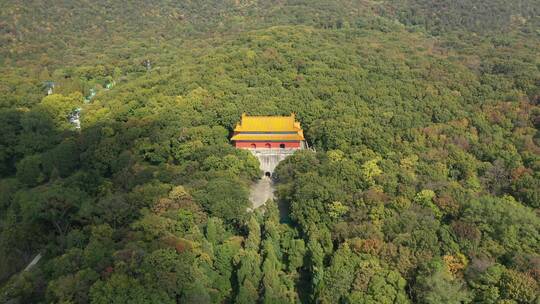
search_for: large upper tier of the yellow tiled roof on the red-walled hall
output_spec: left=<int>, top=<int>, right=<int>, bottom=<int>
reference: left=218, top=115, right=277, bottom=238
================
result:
left=234, top=114, right=302, bottom=132
